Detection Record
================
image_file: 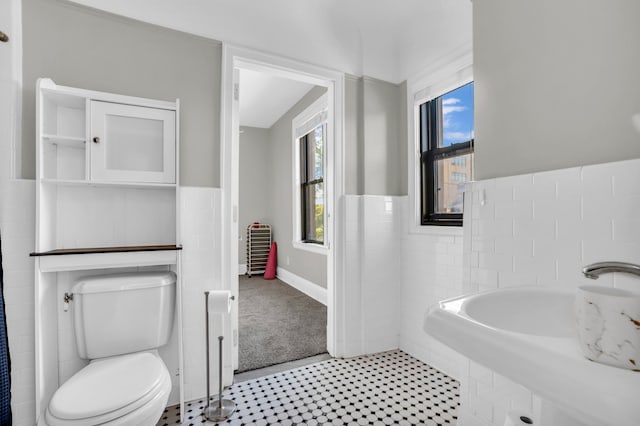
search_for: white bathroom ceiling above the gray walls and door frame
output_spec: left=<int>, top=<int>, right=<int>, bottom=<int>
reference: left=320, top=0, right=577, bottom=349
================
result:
left=72, top=0, right=472, bottom=83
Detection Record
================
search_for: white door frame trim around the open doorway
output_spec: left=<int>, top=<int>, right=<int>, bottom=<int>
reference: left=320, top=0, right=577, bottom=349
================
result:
left=221, top=45, right=344, bottom=374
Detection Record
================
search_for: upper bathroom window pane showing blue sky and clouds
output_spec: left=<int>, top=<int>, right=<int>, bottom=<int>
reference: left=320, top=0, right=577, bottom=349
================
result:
left=438, top=82, right=473, bottom=148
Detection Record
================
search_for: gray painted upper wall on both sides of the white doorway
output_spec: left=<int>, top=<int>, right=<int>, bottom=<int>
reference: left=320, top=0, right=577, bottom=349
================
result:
left=21, top=0, right=407, bottom=195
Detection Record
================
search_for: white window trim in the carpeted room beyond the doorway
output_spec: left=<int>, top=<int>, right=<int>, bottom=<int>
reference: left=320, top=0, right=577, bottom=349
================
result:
left=291, top=93, right=330, bottom=255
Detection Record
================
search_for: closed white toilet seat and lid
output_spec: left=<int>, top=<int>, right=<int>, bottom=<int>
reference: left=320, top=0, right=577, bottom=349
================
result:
left=46, top=352, right=171, bottom=426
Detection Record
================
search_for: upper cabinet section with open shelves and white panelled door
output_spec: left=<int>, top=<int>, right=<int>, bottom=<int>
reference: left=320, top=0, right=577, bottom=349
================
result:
left=37, top=80, right=177, bottom=184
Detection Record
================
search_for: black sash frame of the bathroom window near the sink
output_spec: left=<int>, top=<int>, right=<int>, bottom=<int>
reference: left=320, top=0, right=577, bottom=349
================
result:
left=419, top=85, right=474, bottom=226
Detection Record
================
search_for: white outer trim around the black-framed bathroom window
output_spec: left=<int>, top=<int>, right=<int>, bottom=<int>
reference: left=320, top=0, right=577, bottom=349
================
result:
left=407, top=51, right=473, bottom=236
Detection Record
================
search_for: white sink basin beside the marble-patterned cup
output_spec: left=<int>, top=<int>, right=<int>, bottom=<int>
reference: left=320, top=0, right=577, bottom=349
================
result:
left=424, top=287, right=640, bottom=426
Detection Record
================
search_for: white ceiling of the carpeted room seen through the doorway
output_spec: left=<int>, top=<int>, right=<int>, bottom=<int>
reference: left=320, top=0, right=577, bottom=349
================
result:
left=239, top=69, right=313, bottom=129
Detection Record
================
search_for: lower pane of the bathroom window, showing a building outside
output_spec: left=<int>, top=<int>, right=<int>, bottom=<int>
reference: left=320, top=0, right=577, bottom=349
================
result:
left=434, top=154, right=472, bottom=214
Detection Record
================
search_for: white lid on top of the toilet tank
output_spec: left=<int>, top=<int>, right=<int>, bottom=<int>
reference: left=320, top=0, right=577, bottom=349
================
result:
left=71, top=271, right=176, bottom=294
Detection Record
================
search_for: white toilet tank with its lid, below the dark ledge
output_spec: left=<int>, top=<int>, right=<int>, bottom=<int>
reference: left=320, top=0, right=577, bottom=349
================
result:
left=71, top=271, right=176, bottom=359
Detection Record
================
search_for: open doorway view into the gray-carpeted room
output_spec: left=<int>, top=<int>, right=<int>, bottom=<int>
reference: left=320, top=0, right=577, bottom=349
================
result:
left=237, top=68, right=327, bottom=373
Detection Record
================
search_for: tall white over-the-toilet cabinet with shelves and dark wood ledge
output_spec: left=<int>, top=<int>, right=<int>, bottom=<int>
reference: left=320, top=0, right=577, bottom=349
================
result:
left=32, top=79, right=184, bottom=424
